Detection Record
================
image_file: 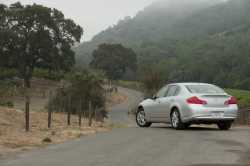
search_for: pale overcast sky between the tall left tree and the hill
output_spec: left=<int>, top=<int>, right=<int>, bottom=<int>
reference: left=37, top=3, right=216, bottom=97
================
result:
left=0, top=0, right=155, bottom=41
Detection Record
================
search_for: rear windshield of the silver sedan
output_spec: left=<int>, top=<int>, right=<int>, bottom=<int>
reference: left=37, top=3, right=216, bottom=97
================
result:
left=186, top=85, right=225, bottom=94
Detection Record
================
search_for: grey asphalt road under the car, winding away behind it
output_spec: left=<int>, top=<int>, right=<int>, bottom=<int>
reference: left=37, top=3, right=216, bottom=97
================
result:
left=0, top=89, right=250, bottom=166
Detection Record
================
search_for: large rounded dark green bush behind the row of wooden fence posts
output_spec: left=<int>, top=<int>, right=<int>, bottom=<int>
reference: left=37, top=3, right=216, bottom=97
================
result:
left=48, top=70, right=107, bottom=121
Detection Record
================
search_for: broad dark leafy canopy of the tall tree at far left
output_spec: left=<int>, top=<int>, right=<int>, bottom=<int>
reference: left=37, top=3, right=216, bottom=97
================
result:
left=0, top=2, right=83, bottom=85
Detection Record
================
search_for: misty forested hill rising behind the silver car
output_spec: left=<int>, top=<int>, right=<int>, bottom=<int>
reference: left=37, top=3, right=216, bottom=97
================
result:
left=76, top=0, right=250, bottom=89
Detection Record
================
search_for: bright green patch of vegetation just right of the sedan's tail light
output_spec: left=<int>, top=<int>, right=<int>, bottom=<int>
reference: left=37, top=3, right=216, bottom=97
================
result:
left=226, top=89, right=250, bottom=108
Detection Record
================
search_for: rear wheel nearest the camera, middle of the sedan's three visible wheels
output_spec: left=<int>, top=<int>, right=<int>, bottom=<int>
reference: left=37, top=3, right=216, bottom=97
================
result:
left=171, top=109, right=186, bottom=130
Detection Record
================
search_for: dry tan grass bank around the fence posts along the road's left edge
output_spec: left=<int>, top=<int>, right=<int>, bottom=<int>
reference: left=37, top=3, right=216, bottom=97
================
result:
left=0, top=108, right=109, bottom=156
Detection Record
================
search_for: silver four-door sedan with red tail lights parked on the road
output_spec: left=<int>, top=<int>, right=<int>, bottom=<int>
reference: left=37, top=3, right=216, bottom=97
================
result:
left=136, top=83, right=238, bottom=130
